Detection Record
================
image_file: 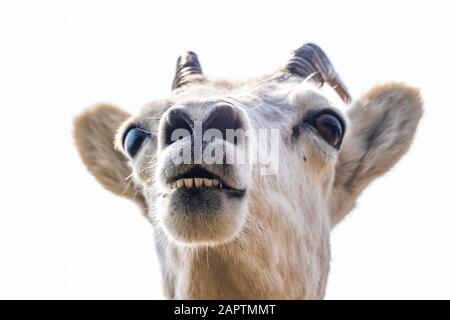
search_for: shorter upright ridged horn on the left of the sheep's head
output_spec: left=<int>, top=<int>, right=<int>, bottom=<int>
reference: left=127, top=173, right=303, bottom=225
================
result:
left=172, top=51, right=204, bottom=90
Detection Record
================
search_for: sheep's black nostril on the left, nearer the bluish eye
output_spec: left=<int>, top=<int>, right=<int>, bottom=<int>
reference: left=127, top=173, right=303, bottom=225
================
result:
left=164, top=109, right=194, bottom=145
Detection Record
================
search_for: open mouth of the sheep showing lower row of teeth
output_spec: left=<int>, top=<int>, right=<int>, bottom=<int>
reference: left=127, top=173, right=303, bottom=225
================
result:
left=171, top=166, right=237, bottom=190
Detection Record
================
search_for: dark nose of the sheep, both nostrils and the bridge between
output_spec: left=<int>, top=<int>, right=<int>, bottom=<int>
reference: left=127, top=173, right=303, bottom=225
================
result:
left=164, top=105, right=243, bottom=145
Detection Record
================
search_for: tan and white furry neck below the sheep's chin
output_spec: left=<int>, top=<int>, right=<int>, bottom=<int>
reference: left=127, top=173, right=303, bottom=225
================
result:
left=157, top=198, right=329, bottom=299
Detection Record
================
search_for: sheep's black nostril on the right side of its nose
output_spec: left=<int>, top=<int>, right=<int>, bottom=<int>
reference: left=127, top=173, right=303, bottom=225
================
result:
left=203, top=105, right=243, bottom=139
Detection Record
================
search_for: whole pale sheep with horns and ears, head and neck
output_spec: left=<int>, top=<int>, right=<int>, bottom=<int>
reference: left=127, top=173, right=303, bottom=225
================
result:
left=75, top=44, right=422, bottom=298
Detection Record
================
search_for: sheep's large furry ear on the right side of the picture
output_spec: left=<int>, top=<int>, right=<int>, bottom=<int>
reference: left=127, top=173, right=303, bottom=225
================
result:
left=330, top=84, right=422, bottom=225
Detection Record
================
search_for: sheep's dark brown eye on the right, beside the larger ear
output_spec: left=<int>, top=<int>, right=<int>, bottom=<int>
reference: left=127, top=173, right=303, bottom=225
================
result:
left=314, top=113, right=344, bottom=149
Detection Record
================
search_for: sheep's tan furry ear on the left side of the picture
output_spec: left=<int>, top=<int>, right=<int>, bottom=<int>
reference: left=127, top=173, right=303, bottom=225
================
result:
left=74, top=104, right=146, bottom=212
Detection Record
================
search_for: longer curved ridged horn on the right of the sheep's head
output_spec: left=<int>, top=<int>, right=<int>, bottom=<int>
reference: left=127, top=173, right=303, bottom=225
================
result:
left=286, top=43, right=351, bottom=103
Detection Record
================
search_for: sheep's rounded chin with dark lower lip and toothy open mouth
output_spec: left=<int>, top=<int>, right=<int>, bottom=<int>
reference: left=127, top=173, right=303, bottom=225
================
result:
left=157, top=168, right=248, bottom=246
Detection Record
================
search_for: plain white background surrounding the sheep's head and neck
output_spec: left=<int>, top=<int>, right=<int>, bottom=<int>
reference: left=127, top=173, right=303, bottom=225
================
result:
left=0, top=0, right=450, bottom=299
